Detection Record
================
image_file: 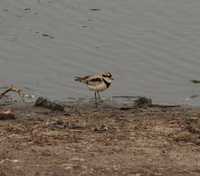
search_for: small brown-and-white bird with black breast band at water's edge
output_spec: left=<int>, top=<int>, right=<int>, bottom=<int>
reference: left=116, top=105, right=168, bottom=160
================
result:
left=74, top=72, right=114, bottom=104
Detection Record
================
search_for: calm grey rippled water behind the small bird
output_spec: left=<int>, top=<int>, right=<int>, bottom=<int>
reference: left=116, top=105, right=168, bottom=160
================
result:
left=0, top=0, right=200, bottom=104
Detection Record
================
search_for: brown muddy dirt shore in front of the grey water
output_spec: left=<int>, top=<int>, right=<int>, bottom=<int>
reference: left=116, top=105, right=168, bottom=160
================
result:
left=0, top=104, right=200, bottom=176
